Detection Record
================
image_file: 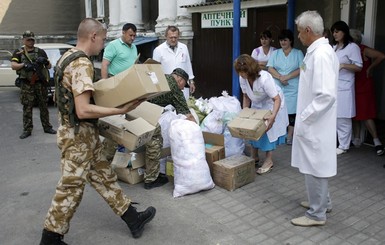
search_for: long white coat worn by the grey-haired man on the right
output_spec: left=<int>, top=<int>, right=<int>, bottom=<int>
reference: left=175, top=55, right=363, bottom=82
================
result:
left=291, top=38, right=339, bottom=178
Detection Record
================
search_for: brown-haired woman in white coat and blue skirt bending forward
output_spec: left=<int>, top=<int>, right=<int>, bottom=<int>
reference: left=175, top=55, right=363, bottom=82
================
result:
left=234, top=54, right=289, bottom=174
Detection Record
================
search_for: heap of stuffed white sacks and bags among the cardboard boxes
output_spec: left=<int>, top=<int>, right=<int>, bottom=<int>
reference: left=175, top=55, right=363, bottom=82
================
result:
left=159, top=92, right=245, bottom=197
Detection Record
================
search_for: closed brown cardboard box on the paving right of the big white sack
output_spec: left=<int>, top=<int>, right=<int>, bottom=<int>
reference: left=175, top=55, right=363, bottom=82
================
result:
left=212, top=155, right=255, bottom=191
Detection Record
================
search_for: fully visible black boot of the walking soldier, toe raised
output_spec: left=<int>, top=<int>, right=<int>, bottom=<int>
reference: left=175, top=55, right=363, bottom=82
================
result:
left=121, top=205, right=156, bottom=238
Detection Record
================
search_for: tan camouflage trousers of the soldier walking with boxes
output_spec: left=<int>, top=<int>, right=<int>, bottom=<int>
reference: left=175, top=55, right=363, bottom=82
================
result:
left=44, top=122, right=131, bottom=234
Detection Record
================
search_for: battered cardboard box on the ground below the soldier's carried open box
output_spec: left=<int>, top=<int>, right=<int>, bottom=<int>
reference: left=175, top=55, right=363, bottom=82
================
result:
left=111, top=151, right=145, bottom=184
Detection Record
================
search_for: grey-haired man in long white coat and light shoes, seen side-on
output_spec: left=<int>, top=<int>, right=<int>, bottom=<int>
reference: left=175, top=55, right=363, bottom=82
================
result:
left=291, top=11, right=339, bottom=226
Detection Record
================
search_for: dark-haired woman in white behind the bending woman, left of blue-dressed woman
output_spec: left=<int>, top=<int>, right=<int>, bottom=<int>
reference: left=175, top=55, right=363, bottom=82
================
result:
left=251, top=30, right=275, bottom=70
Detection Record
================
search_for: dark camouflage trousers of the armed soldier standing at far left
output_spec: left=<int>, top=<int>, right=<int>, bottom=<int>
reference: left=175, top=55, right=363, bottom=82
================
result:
left=20, top=82, right=52, bottom=132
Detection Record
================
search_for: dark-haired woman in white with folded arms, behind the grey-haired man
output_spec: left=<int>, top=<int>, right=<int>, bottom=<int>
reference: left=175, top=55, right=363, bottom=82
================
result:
left=330, top=21, right=362, bottom=155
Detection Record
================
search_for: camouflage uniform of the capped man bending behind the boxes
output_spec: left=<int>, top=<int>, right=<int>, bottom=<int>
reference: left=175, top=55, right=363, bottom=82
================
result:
left=144, top=75, right=190, bottom=183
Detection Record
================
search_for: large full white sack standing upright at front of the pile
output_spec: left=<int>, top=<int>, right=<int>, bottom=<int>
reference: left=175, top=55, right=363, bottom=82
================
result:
left=169, top=119, right=215, bottom=197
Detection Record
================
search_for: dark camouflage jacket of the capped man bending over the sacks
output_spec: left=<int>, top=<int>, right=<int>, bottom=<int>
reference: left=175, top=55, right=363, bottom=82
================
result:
left=149, top=75, right=190, bottom=114
